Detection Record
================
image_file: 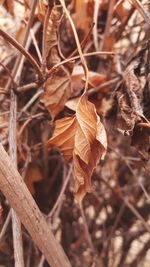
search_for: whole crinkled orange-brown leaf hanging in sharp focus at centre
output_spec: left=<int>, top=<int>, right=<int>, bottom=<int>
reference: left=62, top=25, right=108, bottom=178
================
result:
left=47, top=93, right=107, bottom=203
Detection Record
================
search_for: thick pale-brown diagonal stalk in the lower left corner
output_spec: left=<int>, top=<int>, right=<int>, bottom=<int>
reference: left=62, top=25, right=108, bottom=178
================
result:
left=0, top=144, right=71, bottom=267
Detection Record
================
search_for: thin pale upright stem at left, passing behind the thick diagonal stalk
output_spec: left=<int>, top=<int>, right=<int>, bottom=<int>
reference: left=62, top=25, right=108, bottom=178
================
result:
left=6, top=0, right=37, bottom=267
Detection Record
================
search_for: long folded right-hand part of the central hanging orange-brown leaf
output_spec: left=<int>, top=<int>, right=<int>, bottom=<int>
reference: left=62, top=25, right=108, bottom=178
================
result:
left=73, top=94, right=107, bottom=203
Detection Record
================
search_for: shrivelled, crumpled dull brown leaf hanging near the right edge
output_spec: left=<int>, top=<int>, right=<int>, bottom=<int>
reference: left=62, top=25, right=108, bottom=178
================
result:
left=112, top=60, right=145, bottom=132
